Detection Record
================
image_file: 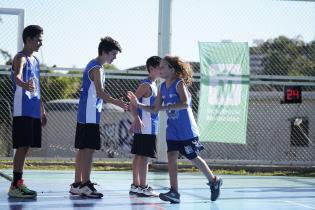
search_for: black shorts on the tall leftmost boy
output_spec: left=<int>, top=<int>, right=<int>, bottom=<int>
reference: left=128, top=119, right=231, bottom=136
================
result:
left=12, top=116, right=42, bottom=149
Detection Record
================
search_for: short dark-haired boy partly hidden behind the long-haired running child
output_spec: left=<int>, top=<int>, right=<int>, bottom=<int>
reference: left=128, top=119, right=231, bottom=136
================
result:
left=129, top=56, right=161, bottom=197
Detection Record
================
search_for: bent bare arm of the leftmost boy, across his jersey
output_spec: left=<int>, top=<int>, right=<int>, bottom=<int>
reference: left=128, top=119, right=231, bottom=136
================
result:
left=13, top=54, right=35, bottom=92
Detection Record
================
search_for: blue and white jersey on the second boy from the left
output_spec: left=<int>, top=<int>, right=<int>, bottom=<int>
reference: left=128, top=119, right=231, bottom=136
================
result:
left=77, top=59, right=105, bottom=124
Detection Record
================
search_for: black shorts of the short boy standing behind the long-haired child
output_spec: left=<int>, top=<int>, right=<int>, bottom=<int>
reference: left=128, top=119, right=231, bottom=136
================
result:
left=131, top=134, right=156, bottom=158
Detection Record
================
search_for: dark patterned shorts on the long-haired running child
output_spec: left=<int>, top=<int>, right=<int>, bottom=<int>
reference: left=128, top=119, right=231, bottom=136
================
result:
left=166, top=137, right=204, bottom=160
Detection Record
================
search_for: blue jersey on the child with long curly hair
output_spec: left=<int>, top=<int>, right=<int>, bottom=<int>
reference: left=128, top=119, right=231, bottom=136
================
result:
left=160, top=78, right=199, bottom=141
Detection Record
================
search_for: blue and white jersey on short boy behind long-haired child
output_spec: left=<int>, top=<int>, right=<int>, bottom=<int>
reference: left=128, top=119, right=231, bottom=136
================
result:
left=136, top=79, right=159, bottom=135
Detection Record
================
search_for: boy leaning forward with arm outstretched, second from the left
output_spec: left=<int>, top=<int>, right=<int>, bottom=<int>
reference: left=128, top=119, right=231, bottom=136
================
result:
left=69, top=37, right=128, bottom=198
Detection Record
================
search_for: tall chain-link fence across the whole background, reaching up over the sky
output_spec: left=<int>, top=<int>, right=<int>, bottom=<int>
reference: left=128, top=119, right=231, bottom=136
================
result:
left=0, top=0, right=315, bottom=165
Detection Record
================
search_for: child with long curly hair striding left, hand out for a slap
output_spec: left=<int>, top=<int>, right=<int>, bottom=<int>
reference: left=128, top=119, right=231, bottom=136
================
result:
left=128, top=56, right=223, bottom=203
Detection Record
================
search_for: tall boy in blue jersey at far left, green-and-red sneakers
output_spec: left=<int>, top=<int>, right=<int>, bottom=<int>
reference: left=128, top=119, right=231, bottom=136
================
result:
left=8, top=25, right=47, bottom=198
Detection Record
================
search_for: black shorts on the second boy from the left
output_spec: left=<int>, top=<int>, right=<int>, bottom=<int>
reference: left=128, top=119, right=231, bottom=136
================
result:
left=74, top=123, right=101, bottom=150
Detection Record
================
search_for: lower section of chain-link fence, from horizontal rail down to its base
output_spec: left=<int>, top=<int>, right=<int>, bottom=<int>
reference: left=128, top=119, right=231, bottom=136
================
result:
left=0, top=67, right=315, bottom=165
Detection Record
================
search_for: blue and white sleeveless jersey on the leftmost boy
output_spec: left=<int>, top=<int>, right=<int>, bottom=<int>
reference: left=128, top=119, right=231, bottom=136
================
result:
left=11, top=52, right=40, bottom=119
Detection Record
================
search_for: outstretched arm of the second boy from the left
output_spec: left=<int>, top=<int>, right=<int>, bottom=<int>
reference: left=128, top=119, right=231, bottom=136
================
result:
left=89, top=67, right=128, bottom=110
